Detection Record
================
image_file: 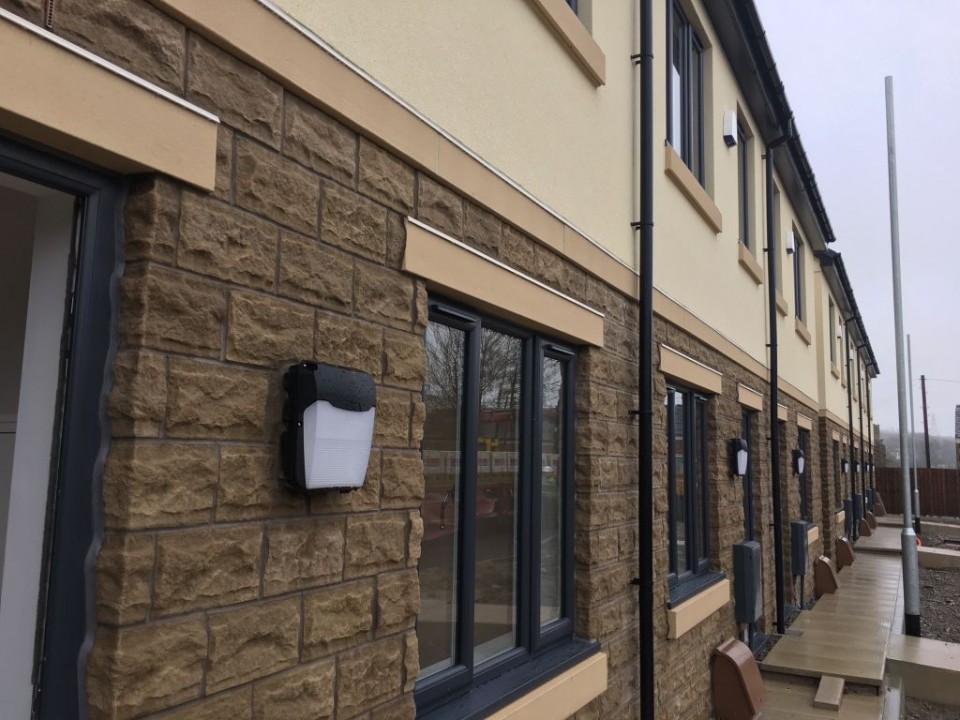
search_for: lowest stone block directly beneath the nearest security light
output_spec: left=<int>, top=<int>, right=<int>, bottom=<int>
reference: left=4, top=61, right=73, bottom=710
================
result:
left=253, top=660, right=337, bottom=720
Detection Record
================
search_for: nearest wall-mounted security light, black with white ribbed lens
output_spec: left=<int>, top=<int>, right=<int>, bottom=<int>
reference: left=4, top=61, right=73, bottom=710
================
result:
left=280, top=362, right=377, bottom=490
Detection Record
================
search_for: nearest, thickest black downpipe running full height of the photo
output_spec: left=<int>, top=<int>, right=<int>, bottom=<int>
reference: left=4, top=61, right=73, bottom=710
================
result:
left=632, top=0, right=656, bottom=720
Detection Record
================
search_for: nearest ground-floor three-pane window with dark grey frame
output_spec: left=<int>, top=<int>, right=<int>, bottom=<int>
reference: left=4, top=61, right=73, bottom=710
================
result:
left=416, top=299, right=595, bottom=718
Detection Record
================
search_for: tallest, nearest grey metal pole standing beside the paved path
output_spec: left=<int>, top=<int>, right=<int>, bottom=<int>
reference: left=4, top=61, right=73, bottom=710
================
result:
left=885, top=75, right=920, bottom=637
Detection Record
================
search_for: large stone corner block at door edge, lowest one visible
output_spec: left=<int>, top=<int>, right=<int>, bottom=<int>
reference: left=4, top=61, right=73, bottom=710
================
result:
left=87, top=618, right=207, bottom=720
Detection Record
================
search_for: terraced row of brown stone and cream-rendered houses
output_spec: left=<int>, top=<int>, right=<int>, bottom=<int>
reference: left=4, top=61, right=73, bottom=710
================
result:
left=0, top=0, right=877, bottom=720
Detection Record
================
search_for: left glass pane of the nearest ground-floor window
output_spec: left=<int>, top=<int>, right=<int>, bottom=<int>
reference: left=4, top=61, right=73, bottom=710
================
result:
left=417, top=323, right=466, bottom=677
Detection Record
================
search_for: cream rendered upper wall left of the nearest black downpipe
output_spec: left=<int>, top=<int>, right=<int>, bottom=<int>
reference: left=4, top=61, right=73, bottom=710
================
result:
left=274, top=0, right=636, bottom=267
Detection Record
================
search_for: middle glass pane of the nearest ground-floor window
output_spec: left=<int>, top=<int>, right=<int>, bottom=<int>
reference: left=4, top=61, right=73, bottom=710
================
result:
left=473, top=328, right=523, bottom=664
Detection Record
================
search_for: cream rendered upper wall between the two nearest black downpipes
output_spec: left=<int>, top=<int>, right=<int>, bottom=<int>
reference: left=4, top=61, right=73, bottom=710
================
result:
left=648, top=0, right=768, bottom=364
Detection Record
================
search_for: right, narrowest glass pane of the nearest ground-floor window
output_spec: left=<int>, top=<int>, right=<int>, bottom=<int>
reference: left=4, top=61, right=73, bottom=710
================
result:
left=540, top=358, right=565, bottom=625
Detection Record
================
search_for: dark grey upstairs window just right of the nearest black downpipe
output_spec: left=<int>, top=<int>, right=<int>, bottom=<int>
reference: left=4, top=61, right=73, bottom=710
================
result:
left=667, top=0, right=704, bottom=185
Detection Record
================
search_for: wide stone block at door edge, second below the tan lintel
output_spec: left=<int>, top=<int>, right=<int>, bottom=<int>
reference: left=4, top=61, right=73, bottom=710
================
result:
left=120, top=265, right=226, bottom=357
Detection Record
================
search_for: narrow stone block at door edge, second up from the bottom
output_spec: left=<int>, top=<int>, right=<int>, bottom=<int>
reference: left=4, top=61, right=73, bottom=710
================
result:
left=97, top=532, right=153, bottom=625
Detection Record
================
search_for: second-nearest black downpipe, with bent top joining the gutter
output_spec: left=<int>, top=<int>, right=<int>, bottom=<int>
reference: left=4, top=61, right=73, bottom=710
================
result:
left=765, top=132, right=793, bottom=635
